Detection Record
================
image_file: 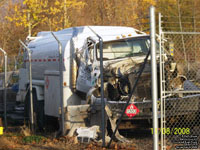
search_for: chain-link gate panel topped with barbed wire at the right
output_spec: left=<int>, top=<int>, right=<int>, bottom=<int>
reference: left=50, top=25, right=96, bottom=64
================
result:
left=158, top=14, right=200, bottom=150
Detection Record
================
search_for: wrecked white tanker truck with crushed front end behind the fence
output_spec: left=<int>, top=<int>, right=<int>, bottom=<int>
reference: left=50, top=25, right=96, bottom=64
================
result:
left=17, top=26, right=184, bottom=138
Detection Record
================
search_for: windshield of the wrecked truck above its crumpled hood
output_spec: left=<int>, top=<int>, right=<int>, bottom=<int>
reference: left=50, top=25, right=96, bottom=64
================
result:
left=97, top=37, right=150, bottom=60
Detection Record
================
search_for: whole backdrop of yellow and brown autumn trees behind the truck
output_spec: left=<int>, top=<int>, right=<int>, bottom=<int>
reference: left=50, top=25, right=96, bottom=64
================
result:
left=0, top=0, right=200, bottom=61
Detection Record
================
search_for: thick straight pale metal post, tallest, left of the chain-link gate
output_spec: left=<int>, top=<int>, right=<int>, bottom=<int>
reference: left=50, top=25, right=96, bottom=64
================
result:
left=150, top=6, right=158, bottom=150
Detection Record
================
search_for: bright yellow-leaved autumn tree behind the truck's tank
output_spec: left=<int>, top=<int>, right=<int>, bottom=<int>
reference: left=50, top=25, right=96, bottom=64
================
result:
left=6, top=0, right=84, bottom=35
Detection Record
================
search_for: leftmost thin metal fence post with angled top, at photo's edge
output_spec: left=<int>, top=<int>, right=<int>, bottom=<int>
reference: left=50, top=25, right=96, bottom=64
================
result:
left=0, top=48, right=7, bottom=129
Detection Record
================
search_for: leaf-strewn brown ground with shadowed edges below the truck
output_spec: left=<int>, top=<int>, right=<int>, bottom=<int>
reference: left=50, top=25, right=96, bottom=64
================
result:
left=0, top=103, right=153, bottom=150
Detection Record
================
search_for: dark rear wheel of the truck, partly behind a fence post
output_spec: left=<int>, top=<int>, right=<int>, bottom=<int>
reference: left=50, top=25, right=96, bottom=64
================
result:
left=24, top=89, right=44, bottom=131
